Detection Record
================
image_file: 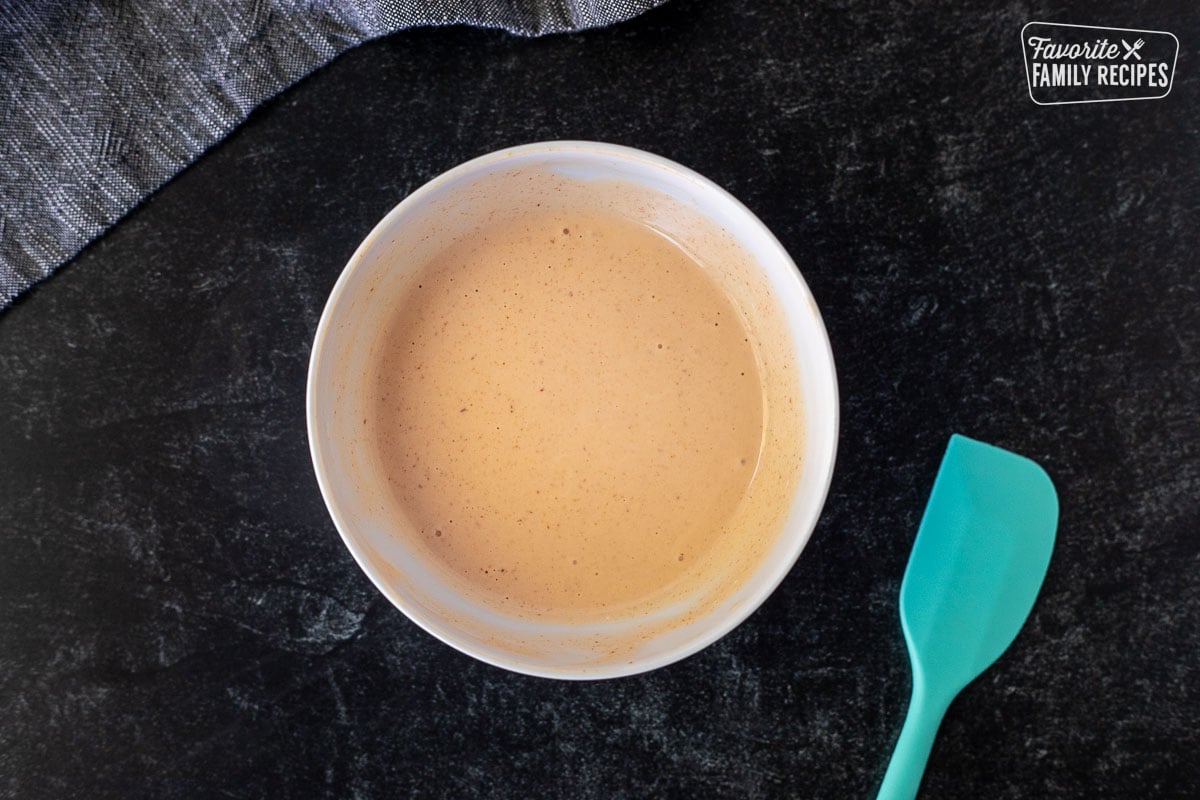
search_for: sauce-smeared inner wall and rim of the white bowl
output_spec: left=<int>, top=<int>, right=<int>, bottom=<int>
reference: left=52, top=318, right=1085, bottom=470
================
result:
left=313, top=143, right=836, bottom=676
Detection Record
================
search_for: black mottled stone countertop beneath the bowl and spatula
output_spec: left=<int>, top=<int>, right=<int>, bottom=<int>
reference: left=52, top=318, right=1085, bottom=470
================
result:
left=0, top=0, right=1200, bottom=800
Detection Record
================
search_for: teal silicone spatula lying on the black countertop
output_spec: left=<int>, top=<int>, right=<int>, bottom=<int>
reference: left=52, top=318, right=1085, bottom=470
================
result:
left=878, top=434, right=1058, bottom=800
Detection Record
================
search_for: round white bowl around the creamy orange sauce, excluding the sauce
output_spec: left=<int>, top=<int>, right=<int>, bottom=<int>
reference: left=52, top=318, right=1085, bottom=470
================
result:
left=307, top=142, right=838, bottom=679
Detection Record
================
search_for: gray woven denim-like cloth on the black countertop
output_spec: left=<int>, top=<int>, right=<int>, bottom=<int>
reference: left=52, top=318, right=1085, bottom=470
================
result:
left=0, top=0, right=664, bottom=309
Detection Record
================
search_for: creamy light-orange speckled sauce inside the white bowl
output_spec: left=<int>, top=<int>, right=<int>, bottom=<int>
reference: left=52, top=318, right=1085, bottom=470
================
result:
left=364, top=210, right=763, bottom=620
